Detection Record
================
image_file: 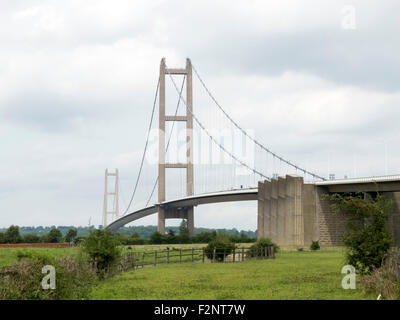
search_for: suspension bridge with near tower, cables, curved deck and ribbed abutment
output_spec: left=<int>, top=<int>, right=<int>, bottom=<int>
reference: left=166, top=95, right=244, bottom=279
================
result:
left=105, top=58, right=400, bottom=245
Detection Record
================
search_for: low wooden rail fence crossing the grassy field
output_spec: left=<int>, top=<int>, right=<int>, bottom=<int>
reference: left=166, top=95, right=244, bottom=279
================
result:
left=113, top=246, right=275, bottom=272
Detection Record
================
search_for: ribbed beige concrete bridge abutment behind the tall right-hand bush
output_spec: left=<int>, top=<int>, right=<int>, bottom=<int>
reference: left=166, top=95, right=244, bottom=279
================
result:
left=257, top=175, right=400, bottom=245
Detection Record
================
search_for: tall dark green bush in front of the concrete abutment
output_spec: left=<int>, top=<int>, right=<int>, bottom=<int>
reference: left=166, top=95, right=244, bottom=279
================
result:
left=330, top=194, right=393, bottom=274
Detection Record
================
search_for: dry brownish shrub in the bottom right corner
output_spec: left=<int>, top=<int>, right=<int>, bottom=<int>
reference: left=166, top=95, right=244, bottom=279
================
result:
left=361, top=249, right=400, bottom=300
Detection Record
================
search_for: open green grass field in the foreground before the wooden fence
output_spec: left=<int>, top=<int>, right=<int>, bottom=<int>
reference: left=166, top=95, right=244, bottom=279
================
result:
left=91, top=249, right=374, bottom=300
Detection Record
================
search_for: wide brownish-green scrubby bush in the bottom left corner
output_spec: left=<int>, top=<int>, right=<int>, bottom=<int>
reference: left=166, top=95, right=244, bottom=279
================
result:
left=0, top=251, right=96, bottom=300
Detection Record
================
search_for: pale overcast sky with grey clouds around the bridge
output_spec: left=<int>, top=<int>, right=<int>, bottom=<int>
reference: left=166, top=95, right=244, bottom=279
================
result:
left=0, top=0, right=400, bottom=230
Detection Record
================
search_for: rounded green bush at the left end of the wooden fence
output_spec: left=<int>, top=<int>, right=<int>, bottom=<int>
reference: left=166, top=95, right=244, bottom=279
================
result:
left=82, top=230, right=121, bottom=278
